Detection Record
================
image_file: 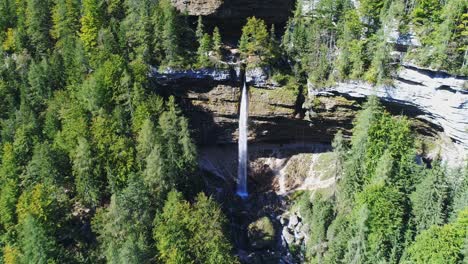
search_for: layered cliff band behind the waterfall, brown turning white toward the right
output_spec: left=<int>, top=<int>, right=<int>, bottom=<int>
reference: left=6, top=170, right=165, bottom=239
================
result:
left=153, top=65, right=468, bottom=163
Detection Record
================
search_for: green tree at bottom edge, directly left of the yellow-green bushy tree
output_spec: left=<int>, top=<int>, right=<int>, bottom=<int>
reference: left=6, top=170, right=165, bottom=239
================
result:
left=93, top=174, right=154, bottom=263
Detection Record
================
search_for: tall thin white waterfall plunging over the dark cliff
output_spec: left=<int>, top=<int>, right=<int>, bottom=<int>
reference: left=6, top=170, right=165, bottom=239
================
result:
left=237, top=81, right=249, bottom=198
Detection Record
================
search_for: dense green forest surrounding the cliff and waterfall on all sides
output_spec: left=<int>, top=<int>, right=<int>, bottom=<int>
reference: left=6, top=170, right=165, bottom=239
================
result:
left=0, top=0, right=468, bottom=264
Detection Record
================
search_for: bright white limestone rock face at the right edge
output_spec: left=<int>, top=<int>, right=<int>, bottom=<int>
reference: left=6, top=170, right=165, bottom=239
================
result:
left=309, top=64, right=468, bottom=163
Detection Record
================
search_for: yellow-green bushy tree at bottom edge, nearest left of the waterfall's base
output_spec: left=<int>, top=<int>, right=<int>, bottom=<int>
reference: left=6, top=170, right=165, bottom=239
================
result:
left=154, top=192, right=237, bottom=264
